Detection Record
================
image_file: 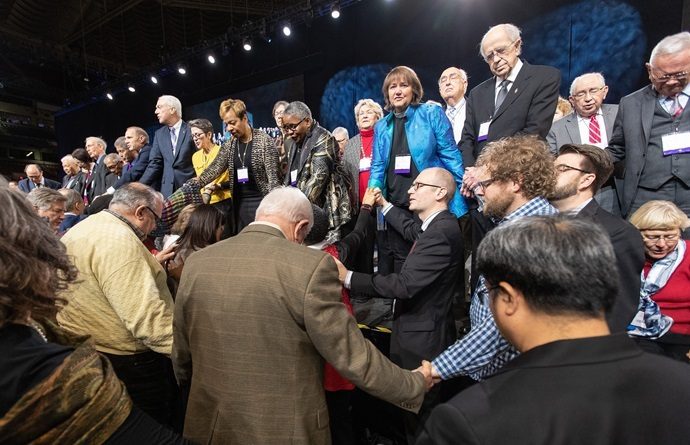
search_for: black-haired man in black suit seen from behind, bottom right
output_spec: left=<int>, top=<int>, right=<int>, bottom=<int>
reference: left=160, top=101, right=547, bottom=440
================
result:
left=417, top=217, right=690, bottom=445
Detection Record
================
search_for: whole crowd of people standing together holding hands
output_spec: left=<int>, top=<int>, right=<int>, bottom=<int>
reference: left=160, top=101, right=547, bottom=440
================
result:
left=0, top=24, right=690, bottom=444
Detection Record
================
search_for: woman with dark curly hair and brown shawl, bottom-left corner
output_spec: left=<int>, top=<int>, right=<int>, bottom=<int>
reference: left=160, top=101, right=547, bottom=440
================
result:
left=0, top=178, right=186, bottom=444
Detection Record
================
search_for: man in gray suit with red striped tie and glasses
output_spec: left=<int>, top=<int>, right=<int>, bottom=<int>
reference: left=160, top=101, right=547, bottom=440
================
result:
left=546, top=73, right=621, bottom=215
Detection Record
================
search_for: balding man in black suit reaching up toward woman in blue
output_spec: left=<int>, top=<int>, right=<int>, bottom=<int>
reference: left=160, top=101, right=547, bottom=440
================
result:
left=338, top=167, right=463, bottom=439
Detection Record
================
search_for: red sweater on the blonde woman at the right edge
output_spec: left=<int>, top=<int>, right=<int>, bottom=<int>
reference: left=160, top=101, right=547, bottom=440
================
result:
left=644, top=240, right=690, bottom=335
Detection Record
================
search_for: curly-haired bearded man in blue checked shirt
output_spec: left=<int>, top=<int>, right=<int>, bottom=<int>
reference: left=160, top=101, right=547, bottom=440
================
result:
left=432, top=136, right=558, bottom=381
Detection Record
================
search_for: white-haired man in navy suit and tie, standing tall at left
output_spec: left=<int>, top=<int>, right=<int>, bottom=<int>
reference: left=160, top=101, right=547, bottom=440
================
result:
left=139, top=95, right=195, bottom=198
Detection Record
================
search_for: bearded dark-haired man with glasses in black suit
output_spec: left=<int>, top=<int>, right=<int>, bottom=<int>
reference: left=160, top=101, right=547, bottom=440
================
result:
left=551, top=144, right=644, bottom=332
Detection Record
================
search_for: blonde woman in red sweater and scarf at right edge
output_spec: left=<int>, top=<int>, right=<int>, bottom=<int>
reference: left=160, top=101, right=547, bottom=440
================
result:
left=630, top=201, right=690, bottom=363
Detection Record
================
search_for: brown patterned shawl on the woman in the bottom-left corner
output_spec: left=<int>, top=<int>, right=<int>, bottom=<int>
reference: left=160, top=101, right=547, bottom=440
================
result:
left=0, top=322, right=132, bottom=444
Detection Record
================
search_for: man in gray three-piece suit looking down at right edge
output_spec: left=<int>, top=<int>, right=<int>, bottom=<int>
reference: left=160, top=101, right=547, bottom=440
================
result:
left=608, top=31, right=690, bottom=217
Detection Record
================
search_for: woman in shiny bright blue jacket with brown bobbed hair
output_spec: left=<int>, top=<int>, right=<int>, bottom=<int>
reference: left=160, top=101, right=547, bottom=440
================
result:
left=369, top=66, right=467, bottom=273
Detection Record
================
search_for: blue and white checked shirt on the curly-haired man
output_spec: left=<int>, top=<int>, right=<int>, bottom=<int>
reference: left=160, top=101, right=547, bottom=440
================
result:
left=433, top=197, right=558, bottom=380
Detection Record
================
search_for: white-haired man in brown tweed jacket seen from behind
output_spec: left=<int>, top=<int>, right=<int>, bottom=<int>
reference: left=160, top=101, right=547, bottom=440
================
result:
left=173, top=187, right=431, bottom=445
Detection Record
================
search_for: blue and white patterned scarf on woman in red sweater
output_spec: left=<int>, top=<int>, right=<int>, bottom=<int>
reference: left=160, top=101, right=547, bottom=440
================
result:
left=628, top=240, right=685, bottom=339
